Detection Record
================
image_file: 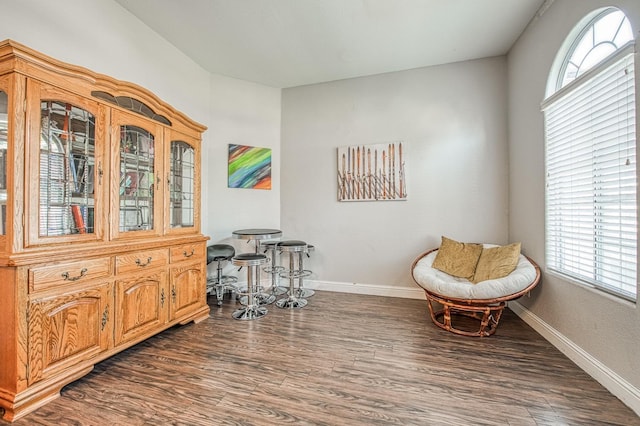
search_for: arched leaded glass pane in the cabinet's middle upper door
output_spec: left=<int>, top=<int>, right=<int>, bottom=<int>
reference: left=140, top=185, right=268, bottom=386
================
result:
left=120, top=126, right=155, bottom=232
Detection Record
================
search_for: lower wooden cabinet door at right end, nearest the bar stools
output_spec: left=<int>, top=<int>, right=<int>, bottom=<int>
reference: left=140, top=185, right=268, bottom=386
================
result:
left=169, top=262, right=206, bottom=321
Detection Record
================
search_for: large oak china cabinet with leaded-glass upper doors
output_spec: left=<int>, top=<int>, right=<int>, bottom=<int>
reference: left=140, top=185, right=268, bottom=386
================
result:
left=0, top=40, right=209, bottom=421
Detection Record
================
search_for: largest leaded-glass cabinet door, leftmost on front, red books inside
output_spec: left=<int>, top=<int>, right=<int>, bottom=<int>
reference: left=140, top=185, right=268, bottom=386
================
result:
left=27, top=82, right=104, bottom=244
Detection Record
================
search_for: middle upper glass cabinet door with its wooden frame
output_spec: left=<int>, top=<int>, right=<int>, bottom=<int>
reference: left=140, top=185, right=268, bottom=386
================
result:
left=112, top=112, right=162, bottom=236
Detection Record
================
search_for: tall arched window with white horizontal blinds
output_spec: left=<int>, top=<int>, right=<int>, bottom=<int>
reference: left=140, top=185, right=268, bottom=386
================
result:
left=543, top=8, right=637, bottom=301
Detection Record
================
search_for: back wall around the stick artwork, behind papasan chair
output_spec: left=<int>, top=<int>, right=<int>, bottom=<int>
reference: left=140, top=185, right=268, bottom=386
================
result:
left=281, top=57, right=508, bottom=297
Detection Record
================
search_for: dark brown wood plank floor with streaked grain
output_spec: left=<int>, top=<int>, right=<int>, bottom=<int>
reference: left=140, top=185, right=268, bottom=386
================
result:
left=14, top=292, right=640, bottom=426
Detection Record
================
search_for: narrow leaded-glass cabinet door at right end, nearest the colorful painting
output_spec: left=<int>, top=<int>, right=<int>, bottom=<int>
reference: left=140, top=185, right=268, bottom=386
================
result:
left=166, top=132, right=200, bottom=233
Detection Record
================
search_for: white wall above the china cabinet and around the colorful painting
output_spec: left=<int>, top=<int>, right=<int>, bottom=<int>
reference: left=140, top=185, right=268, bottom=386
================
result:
left=0, top=0, right=280, bottom=248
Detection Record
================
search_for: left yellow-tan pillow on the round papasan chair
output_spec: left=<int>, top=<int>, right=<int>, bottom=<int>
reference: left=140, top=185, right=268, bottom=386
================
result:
left=431, top=237, right=482, bottom=280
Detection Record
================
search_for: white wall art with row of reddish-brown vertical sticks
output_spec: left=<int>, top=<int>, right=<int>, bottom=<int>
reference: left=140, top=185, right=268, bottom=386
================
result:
left=338, top=142, right=407, bottom=201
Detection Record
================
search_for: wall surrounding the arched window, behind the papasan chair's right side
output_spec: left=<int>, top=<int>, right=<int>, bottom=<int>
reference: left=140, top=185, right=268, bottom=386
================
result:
left=508, top=0, right=640, bottom=413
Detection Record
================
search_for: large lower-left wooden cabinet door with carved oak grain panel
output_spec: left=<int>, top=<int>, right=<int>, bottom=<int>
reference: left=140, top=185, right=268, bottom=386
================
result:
left=28, top=282, right=113, bottom=384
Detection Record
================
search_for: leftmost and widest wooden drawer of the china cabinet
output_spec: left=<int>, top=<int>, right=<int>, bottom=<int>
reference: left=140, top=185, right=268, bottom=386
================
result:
left=29, top=257, right=111, bottom=291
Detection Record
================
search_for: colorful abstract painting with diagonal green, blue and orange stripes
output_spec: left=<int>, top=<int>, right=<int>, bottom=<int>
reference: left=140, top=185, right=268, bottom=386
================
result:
left=229, top=144, right=271, bottom=189
